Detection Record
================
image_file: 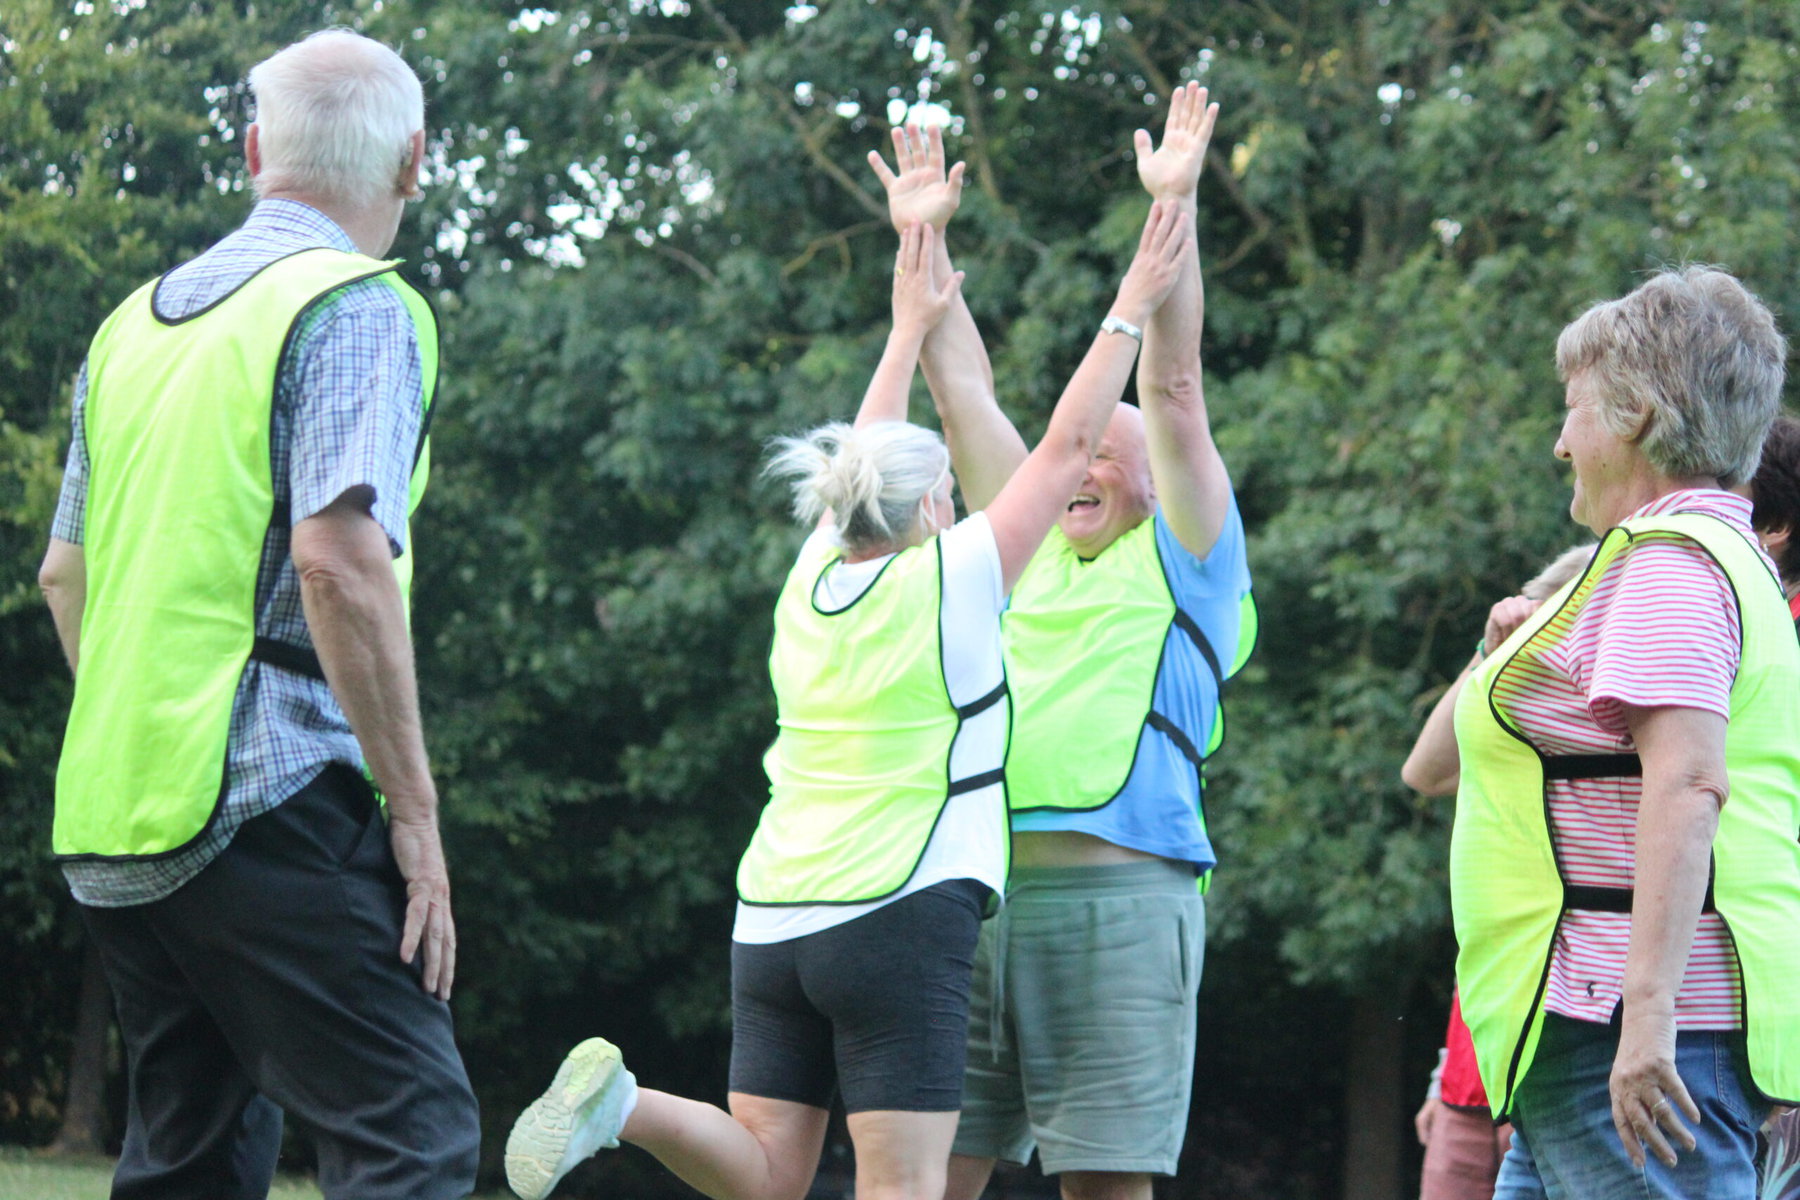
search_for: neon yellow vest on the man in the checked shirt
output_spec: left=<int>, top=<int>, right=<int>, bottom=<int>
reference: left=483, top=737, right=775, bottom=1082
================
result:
left=52, top=248, right=437, bottom=860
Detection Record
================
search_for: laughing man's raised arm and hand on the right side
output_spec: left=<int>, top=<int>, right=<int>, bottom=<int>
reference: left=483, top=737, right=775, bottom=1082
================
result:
left=1136, top=83, right=1231, bottom=558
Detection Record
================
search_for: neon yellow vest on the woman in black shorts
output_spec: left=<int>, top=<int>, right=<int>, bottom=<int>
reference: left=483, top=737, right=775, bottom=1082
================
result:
left=738, top=538, right=1006, bottom=905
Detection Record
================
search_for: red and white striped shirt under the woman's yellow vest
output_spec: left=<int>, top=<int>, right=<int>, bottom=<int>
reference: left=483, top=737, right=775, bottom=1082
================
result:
left=1494, top=488, right=1773, bottom=1029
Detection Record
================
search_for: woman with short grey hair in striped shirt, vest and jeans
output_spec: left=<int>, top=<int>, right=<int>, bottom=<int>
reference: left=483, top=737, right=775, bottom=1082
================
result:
left=1451, top=266, right=1800, bottom=1200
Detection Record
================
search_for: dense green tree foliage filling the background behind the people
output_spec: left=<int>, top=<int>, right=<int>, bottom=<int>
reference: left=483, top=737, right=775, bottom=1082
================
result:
left=0, top=0, right=1800, bottom=1196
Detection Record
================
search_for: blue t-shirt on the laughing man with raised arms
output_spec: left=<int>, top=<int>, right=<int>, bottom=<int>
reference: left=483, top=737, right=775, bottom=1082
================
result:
left=1013, top=497, right=1249, bottom=871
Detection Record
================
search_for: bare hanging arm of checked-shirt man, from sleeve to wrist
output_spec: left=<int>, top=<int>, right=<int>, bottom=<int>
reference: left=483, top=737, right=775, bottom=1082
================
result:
left=295, top=511, right=437, bottom=820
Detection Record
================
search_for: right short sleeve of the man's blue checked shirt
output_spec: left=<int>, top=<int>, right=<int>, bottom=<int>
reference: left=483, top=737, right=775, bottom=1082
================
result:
left=283, top=281, right=423, bottom=556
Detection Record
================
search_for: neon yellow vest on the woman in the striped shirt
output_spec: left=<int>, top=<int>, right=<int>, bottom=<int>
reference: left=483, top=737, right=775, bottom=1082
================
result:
left=1451, top=513, right=1800, bottom=1119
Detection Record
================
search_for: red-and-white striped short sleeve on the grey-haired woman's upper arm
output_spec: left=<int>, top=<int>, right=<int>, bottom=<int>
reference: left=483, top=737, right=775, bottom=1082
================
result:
left=1561, top=534, right=1742, bottom=736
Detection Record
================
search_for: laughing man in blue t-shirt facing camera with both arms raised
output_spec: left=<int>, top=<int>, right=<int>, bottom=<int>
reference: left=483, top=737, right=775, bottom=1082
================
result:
left=871, top=85, right=1255, bottom=1200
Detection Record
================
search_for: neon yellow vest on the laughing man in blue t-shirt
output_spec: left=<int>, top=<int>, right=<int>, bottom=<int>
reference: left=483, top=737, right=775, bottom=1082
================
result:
left=1001, top=520, right=1256, bottom=845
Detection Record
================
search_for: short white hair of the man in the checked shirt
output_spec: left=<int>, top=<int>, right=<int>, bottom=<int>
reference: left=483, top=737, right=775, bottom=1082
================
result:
left=250, top=29, right=425, bottom=205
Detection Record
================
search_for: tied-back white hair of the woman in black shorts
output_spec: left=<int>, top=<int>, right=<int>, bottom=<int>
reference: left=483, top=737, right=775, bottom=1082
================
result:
left=763, top=421, right=950, bottom=552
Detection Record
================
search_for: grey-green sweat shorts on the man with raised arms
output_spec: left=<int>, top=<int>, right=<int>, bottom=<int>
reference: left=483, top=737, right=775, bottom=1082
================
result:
left=954, top=862, right=1206, bottom=1175
